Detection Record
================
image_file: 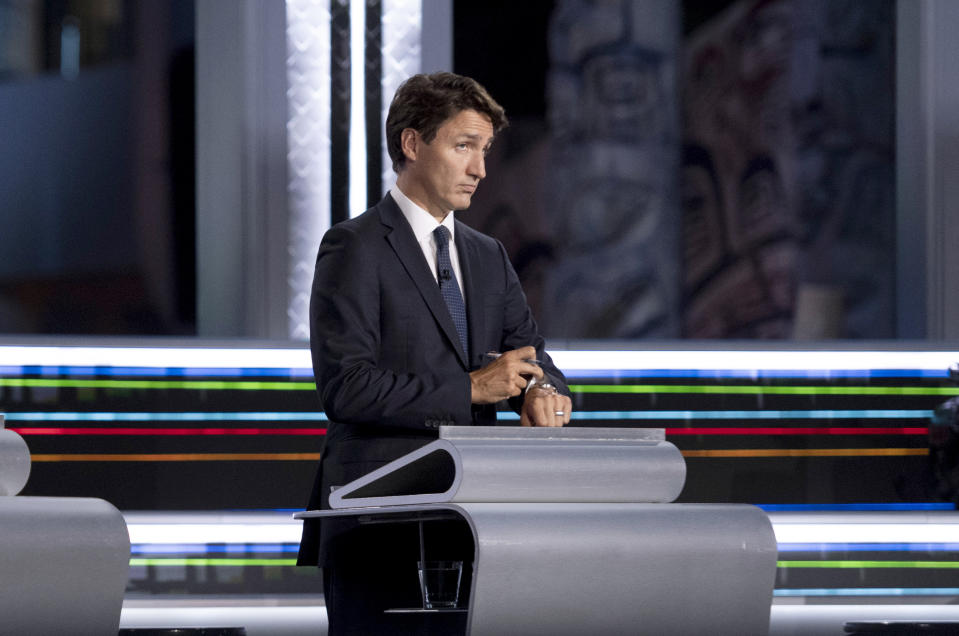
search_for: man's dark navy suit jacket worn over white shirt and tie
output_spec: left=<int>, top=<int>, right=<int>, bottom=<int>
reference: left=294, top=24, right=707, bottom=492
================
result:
left=298, top=195, right=568, bottom=565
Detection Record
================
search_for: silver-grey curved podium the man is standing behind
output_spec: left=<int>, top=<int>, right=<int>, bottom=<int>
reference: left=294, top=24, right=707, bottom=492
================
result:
left=295, top=427, right=776, bottom=635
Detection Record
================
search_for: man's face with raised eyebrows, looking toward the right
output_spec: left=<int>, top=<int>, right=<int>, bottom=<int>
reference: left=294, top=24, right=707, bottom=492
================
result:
left=402, top=110, right=493, bottom=219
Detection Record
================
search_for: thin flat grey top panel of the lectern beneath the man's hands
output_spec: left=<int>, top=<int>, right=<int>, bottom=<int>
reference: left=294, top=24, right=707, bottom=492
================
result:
left=440, top=426, right=666, bottom=442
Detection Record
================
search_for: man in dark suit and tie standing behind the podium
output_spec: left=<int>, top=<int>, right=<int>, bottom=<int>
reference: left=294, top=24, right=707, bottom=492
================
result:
left=299, top=73, right=572, bottom=634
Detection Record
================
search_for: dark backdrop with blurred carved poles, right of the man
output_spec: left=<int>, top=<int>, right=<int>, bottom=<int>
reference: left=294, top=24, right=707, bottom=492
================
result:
left=455, top=0, right=895, bottom=338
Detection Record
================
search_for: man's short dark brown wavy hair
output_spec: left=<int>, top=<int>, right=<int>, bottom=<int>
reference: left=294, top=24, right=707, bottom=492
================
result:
left=386, top=73, right=509, bottom=172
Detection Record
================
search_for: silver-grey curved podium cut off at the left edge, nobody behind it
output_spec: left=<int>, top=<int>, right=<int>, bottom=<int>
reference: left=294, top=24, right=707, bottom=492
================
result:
left=0, top=414, right=130, bottom=636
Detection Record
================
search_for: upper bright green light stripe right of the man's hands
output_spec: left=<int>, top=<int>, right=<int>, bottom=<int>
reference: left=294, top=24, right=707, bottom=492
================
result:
left=569, top=384, right=959, bottom=395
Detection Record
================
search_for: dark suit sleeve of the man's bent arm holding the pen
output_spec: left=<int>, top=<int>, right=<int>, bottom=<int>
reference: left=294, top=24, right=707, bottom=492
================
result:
left=310, top=225, right=471, bottom=430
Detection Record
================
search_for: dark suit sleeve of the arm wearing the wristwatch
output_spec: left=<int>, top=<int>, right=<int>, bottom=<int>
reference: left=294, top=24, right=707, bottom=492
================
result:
left=497, top=242, right=569, bottom=412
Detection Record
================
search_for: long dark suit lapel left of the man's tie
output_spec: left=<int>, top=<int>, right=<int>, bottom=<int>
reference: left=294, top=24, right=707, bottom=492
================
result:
left=378, top=195, right=472, bottom=370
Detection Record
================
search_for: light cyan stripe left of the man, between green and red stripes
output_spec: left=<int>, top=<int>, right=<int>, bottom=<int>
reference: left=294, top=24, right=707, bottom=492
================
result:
left=6, top=411, right=327, bottom=422
